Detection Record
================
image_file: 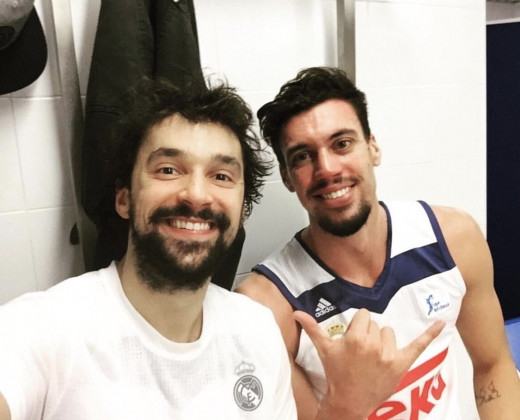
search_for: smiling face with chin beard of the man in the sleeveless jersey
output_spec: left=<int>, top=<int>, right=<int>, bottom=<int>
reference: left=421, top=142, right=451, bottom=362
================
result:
left=280, top=99, right=380, bottom=236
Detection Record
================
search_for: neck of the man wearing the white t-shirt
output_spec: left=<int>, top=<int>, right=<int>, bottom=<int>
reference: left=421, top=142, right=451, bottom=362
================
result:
left=117, top=252, right=209, bottom=343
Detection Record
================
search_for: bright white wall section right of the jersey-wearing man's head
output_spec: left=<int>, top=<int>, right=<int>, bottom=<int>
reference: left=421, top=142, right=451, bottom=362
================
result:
left=356, top=0, right=486, bottom=231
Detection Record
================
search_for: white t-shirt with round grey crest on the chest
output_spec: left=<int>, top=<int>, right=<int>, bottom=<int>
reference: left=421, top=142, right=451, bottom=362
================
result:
left=0, top=263, right=296, bottom=420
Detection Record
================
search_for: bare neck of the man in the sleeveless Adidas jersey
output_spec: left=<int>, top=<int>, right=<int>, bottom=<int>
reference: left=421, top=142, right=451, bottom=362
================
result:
left=302, top=202, right=388, bottom=287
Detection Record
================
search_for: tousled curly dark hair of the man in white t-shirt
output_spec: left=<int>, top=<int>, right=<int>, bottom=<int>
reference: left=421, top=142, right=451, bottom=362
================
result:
left=115, top=78, right=272, bottom=217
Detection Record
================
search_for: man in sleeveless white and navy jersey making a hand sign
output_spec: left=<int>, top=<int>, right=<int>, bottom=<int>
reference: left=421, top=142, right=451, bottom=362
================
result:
left=237, top=68, right=520, bottom=420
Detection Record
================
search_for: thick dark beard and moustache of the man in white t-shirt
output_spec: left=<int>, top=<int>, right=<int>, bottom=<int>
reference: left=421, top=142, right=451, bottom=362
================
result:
left=129, top=204, right=232, bottom=293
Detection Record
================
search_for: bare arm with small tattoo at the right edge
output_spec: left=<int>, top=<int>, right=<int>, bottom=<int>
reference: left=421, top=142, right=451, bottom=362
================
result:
left=434, top=207, right=520, bottom=420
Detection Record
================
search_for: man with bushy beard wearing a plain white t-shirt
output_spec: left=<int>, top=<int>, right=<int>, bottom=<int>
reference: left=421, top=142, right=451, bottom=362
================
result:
left=0, top=79, right=296, bottom=420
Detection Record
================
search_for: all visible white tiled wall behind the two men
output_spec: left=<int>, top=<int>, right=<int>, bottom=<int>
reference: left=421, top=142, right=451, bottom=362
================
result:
left=0, top=0, right=486, bottom=303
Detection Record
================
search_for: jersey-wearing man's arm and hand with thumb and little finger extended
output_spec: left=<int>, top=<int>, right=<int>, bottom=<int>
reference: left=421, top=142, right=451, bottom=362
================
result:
left=236, top=273, right=444, bottom=420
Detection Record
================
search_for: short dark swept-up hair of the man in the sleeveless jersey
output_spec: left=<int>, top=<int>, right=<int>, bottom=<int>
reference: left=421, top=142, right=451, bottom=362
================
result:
left=257, top=67, right=370, bottom=166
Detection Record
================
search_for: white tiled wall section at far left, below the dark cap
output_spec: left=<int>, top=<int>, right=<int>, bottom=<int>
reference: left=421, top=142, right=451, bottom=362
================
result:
left=0, top=0, right=84, bottom=304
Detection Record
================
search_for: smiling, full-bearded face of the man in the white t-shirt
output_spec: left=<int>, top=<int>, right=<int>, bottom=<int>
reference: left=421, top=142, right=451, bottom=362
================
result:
left=116, top=115, right=244, bottom=291
